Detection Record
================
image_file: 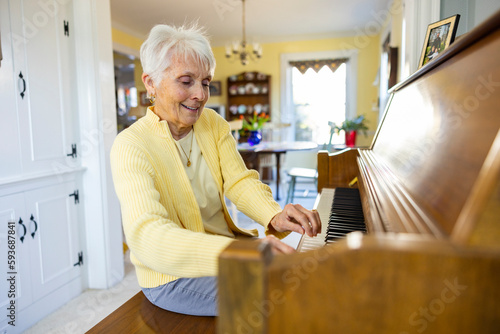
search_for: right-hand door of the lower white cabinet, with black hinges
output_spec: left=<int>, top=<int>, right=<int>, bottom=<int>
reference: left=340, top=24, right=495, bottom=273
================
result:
left=25, top=183, right=83, bottom=300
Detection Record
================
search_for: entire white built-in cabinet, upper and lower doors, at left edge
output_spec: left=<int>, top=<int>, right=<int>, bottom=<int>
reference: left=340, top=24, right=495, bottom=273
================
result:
left=0, top=0, right=86, bottom=333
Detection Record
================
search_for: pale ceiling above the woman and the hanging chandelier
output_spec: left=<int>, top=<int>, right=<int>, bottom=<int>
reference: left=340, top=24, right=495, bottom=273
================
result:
left=110, top=0, right=391, bottom=46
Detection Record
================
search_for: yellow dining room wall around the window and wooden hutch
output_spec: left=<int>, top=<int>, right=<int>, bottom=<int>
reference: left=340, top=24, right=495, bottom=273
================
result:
left=113, top=29, right=380, bottom=145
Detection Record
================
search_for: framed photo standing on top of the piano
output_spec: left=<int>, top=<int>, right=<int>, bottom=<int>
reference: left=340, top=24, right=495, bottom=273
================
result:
left=418, top=14, right=460, bottom=68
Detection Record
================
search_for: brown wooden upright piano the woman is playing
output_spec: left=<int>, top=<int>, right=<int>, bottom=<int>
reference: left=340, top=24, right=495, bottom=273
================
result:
left=217, top=9, right=500, bottom=334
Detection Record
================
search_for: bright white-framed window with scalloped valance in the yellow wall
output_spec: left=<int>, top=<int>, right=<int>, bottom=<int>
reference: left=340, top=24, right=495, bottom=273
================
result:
left=280, top=50, right=357, bottom=148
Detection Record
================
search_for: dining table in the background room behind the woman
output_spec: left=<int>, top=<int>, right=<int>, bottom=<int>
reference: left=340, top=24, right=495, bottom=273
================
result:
left=238, top=141, right=318, bottom=200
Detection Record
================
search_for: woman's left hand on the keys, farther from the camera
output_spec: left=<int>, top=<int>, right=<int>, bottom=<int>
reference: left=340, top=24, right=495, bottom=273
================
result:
left=270, top=204, right=321, bottom=237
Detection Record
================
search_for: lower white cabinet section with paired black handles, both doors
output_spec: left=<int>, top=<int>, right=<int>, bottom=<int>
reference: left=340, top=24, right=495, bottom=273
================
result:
left=0, top=181, right=84, bottom=333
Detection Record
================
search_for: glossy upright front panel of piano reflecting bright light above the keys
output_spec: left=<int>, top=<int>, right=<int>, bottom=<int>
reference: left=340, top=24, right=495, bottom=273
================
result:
left=372, top=31, right=500, bottom=235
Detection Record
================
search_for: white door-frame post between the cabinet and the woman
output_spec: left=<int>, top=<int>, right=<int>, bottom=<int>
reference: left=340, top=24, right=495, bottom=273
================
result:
left=75, top=0, right=124, bottom=289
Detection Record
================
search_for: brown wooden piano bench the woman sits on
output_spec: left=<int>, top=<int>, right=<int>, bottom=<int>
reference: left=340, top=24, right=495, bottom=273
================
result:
left=87, top=291, right=215, bottom=334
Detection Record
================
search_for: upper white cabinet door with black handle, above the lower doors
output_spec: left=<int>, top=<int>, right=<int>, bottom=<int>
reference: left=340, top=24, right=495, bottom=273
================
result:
left=0, top=0, right=79, bottom=179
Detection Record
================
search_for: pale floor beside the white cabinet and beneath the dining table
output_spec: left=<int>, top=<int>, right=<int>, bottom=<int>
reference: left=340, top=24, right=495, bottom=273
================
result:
left=25, top=179, right=315, bottom=334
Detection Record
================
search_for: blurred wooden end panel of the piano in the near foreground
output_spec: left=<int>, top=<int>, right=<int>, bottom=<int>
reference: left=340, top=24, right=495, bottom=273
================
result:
left=221, top=234, right=500, bottom=334
